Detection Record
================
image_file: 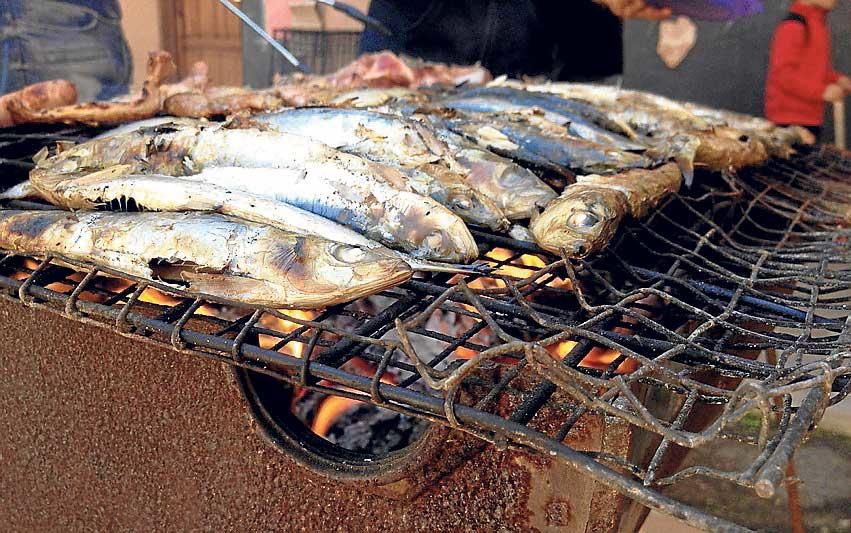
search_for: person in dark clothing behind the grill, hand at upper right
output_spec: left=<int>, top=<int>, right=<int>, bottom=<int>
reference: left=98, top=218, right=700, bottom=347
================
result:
left=361, top=0, right=670, bottom=81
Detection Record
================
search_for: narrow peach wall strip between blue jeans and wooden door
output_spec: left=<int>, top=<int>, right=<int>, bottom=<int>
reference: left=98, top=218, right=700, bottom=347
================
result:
left=119, top=0, right=162, bottom=89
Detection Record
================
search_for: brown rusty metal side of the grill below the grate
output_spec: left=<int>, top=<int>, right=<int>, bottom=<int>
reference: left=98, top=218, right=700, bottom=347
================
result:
left=0, top=301, right=644, bottom=531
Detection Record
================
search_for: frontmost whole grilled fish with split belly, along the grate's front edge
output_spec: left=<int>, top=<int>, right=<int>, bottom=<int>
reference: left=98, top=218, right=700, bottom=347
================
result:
left=0, top=211, right=411, bottom=309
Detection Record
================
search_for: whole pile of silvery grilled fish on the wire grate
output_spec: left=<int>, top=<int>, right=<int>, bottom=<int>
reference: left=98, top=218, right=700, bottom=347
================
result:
left=0, top=60, right=803, bottom=309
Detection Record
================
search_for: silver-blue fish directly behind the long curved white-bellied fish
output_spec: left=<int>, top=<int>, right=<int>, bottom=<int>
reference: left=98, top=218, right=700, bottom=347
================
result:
left=252, top=108, right=509, bottom=231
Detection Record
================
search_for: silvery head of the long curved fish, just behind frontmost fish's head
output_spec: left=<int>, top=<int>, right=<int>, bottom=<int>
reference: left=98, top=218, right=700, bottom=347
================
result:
left=390, top=193, right=479, bottom=263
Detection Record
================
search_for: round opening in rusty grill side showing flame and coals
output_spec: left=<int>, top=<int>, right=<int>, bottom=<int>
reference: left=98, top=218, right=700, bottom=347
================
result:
left=234, top=368, right=442, bottom=485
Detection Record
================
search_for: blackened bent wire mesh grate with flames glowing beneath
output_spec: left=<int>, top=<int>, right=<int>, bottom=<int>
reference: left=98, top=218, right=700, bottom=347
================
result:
left=0, top=124, right=851, bottom=529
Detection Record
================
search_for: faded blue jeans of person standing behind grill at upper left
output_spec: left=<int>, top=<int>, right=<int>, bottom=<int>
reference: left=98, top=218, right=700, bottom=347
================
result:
left=0, top=0, right=133, bottom=101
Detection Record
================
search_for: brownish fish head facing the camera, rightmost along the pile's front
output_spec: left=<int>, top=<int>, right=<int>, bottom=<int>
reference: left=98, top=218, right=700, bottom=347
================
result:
left=529, top=185, right=626, bottom=257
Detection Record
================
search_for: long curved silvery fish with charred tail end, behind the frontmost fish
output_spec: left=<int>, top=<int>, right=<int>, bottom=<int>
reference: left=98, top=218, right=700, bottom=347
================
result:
left=30, top=122, right=478, bottom=263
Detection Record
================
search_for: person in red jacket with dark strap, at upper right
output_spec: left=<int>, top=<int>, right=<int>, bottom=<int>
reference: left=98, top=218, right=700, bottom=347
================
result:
left=765, top=0, right=851, bottom=138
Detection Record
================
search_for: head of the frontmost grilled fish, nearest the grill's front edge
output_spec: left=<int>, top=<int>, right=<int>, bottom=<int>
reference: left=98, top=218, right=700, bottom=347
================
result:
left=289, top=237, right=412, bottom=300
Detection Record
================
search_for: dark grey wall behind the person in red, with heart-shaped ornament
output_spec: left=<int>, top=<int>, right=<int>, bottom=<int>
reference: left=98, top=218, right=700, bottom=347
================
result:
left=624, top=0, right=851, bottom=140
